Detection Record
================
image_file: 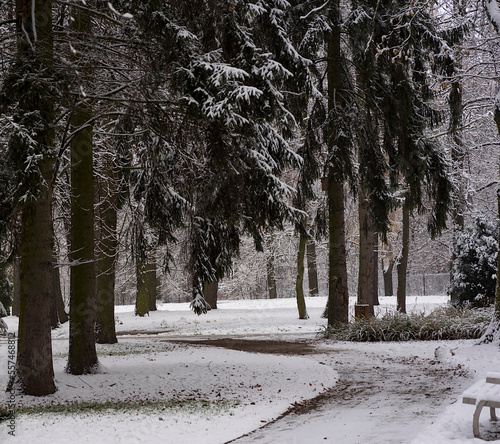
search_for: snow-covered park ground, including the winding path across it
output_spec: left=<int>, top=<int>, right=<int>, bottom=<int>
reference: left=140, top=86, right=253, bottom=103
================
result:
left=0, top=296, right=500, bottom=444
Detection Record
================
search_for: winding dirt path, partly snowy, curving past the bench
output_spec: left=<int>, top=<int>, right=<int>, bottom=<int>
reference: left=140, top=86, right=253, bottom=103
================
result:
left=171, top=338, right=470, bottom=444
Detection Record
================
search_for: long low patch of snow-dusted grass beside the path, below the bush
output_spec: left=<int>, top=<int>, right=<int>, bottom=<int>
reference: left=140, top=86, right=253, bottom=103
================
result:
left=319, top=306, right=493, bottom=342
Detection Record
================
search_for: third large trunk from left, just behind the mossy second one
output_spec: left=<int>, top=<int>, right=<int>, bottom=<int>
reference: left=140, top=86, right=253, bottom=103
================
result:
left=95, top=154, right=118, bottom=344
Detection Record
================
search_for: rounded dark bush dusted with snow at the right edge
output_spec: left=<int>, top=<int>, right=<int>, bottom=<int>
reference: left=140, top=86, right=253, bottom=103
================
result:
left=449, top=217, right=498, bottom=307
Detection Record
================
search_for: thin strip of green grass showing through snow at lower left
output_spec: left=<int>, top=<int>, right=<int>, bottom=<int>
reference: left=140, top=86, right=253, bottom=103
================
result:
left=9, top=399, right=239, bottom=415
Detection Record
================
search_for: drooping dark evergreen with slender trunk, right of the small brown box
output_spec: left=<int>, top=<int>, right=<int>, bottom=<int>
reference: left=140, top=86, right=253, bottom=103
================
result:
left=350, top=2, right=454, bottom=311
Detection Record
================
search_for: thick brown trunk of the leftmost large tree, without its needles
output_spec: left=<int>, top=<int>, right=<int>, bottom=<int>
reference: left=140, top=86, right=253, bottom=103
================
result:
left=9, top=0, right=57, bottom=396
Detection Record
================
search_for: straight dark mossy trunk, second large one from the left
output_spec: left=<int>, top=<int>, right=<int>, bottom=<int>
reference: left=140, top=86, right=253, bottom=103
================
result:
left=66, top=8, right=98, bottom=375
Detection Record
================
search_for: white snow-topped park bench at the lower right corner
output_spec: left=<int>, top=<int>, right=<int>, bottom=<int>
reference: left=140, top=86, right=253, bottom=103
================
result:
left=462, top=373, right=500, bottom=441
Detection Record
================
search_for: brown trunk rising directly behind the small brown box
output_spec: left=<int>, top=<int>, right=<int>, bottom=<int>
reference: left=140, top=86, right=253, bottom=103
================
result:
left=357, top=188, right=378, bottom=316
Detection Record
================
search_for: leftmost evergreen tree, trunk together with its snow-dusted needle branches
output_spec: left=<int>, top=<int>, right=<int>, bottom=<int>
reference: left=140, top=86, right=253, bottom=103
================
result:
left=0, top=0, right=57, bottom=396
